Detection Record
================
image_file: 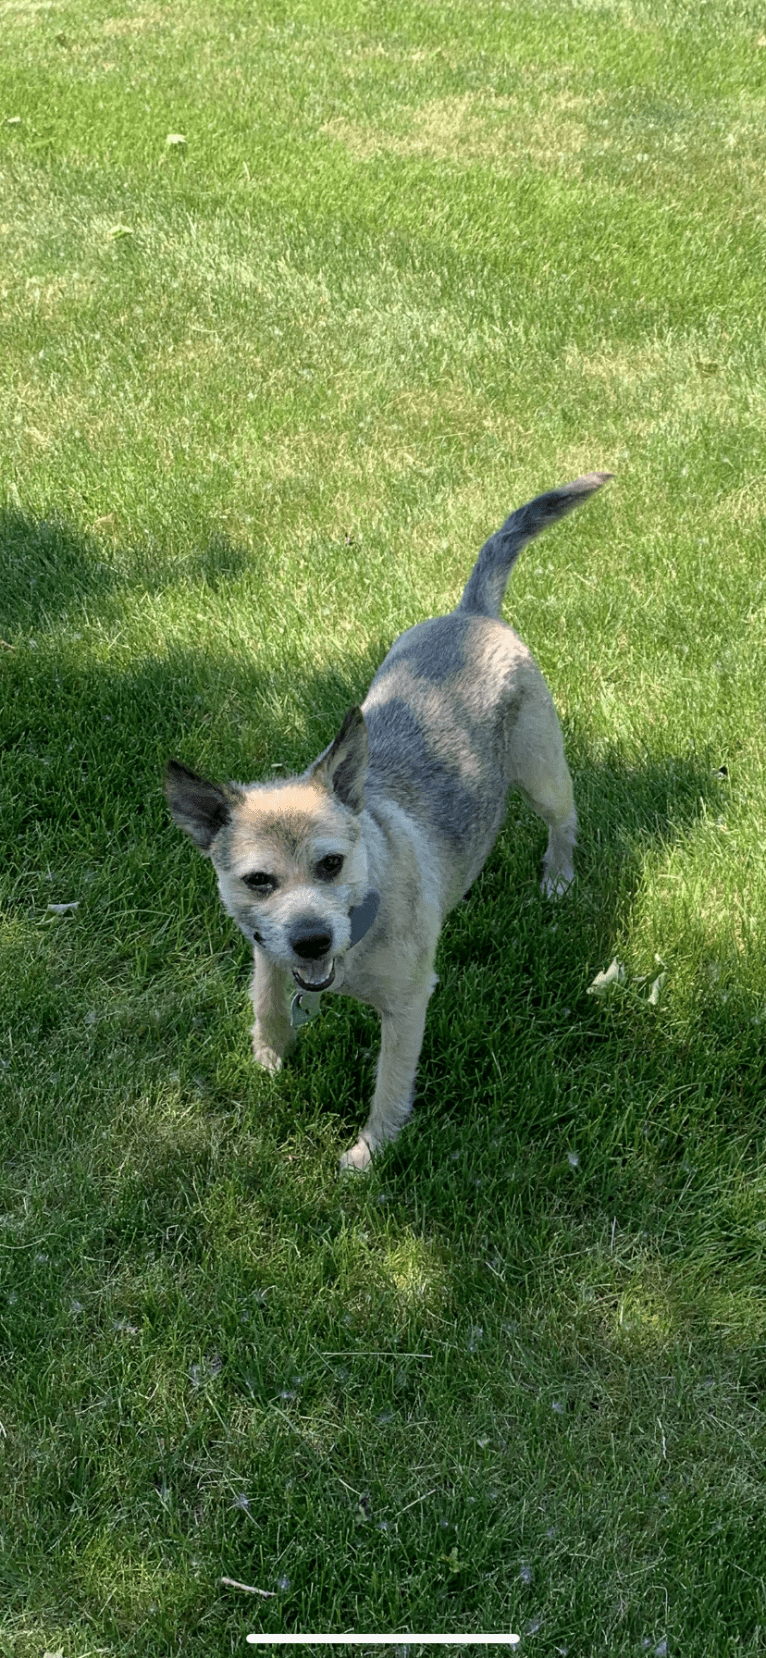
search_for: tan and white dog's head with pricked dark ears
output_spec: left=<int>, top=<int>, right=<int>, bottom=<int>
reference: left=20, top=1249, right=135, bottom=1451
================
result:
left=166, top=708, right=368, bottom=990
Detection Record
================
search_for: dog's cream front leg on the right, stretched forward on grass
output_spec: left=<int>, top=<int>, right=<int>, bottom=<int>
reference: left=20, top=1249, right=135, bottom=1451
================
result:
left=340, top=975, right=436, bottom=1169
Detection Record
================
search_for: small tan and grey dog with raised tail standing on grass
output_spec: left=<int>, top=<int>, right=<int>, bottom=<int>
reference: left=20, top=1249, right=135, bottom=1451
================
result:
left=166, top=473, right=612, bottom=1169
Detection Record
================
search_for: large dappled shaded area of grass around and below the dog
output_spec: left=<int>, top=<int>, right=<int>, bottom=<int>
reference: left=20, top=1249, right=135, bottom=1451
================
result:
left=3, top=513, right=764, bottom=1653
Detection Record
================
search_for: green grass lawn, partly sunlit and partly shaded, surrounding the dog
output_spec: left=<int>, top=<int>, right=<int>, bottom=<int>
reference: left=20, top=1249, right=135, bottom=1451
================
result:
left=0, top=0, right=766, bottom=1658
